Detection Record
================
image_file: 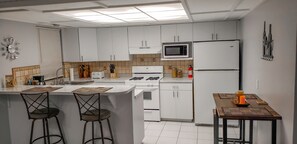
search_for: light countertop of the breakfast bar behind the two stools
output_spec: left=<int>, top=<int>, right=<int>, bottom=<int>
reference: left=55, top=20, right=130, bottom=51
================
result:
left=0, top=83, right=135, bottom=95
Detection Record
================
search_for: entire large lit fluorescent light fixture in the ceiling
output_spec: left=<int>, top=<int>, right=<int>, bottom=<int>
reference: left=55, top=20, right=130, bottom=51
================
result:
left=53, top=3, right=189, bottom=23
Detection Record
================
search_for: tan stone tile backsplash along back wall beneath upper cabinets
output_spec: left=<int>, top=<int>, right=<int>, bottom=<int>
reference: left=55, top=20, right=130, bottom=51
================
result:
left=64, top=54, right=193, bottom=77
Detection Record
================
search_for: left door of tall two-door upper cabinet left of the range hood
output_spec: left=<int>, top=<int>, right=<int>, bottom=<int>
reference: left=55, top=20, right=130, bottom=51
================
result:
left=97, top=28, right=113, bottom=61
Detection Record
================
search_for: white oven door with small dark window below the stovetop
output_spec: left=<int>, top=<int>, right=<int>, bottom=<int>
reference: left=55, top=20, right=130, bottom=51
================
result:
left=136, top=87, right=160, bottom=110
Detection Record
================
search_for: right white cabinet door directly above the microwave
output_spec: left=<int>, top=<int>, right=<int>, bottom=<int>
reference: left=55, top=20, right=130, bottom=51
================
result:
left=176, top=24, right=193, bottom=42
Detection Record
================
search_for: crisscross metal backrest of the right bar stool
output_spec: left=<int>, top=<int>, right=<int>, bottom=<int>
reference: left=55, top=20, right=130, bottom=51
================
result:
left=73, top=92, right=101, bottom=120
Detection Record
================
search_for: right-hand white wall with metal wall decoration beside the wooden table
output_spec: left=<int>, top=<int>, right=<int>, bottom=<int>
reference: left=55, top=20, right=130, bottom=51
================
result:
left=242, top=0, right=297, bottom=144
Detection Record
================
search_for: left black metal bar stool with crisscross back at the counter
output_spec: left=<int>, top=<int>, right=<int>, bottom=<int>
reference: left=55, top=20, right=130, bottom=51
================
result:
left=20, top=92, right=65, bottom=144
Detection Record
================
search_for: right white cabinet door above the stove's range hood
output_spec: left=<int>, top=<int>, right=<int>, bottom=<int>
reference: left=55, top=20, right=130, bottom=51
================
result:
left=144, top=26, right=161, bottom=49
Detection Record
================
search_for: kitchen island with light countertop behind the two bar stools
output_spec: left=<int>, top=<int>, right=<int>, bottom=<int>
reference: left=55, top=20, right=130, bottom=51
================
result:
left=0, top=83, right=144, bottom=144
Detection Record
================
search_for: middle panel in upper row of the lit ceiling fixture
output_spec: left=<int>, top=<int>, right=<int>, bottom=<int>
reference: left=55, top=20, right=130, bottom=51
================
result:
left=94, top=7, right=140, bottom=15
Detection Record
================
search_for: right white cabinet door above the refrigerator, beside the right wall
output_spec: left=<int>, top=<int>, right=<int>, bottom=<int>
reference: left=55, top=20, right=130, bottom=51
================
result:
left=215, top=21, right=237, bottom=40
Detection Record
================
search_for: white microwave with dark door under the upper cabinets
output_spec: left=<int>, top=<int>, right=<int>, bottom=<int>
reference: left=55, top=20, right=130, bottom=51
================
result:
left=162, top=43, right=192, bottom=59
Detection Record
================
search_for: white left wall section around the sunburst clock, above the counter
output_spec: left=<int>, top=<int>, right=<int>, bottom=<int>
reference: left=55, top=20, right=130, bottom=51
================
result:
left=0, top=19, right=40, bottom=86
